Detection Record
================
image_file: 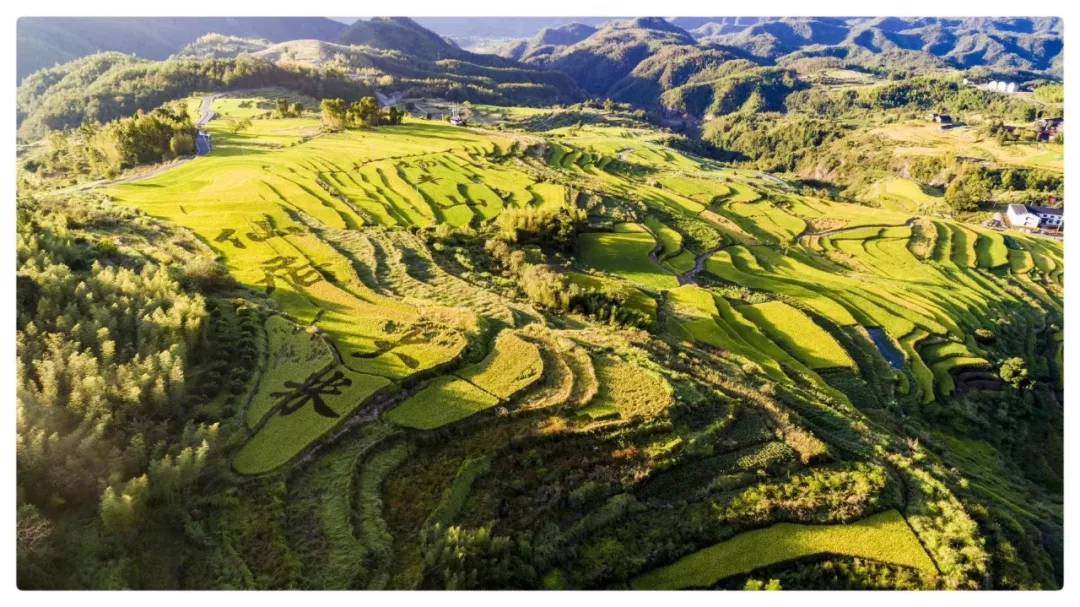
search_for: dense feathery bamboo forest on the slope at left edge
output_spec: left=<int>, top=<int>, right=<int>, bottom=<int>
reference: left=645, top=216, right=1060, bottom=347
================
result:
left=16, top=191, right=236, bottom=588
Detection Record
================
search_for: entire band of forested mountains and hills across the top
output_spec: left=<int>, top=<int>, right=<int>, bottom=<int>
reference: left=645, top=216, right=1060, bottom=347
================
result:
left=16, top=17, right=1064, bottom=136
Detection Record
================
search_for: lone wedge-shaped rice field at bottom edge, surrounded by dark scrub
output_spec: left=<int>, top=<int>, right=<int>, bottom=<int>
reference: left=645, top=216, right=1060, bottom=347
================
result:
left=633, top=510, right=936, bottom=590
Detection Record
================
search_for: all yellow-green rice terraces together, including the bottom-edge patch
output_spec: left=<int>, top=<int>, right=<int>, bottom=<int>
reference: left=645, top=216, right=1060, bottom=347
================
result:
left=95, top=99, right=1064, bottom=588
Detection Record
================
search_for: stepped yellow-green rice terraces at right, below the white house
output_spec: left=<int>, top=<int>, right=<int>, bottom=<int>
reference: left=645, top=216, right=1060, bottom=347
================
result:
left=705, top=203, right=1062, bottom=403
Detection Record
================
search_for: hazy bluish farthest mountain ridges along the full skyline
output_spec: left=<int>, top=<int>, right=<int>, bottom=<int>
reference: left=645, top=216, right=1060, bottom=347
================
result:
left=16, top=17, right=1064, bottom=81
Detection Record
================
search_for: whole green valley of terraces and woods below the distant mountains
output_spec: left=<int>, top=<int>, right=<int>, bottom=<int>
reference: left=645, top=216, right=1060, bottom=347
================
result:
left=16, top=15, right=1065, bottom=590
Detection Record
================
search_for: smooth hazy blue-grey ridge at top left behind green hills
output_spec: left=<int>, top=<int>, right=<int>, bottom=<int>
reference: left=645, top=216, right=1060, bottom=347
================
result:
left=15, top=17, right=348, bottom=80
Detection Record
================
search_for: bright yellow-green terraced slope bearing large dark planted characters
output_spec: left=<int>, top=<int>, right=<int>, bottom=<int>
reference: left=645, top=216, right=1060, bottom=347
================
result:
left=108, top=98, right=583, bottom=473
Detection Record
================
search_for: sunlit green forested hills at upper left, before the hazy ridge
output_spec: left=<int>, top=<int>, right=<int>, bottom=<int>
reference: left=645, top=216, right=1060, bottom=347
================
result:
left=16, top=18, right=583, bottom=140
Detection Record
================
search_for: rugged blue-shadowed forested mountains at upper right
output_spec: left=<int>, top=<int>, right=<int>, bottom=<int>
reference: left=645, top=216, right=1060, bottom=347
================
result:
left=481, top=17, right=1063, bottom=119
